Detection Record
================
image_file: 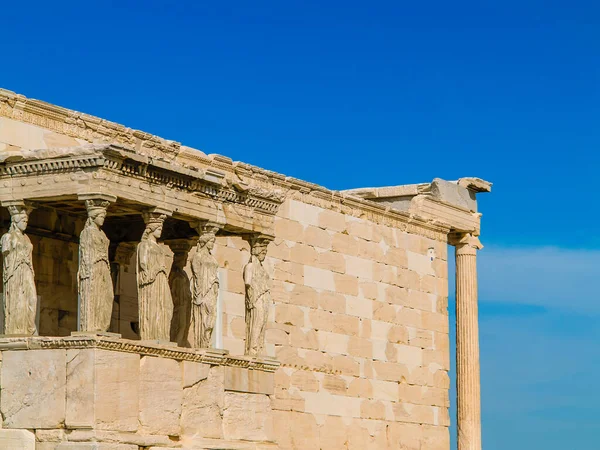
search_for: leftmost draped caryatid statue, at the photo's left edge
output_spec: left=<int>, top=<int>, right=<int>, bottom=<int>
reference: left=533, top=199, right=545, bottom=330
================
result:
left=1, top=202, right=38, bottom=336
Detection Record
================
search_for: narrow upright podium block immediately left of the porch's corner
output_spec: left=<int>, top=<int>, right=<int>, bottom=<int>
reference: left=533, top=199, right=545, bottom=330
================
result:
left=65, top=349, right=96, bottom=428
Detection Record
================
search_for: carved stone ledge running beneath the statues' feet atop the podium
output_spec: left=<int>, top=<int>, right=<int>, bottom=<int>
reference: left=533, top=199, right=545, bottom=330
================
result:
left=0, top=335, right=280, bottom=372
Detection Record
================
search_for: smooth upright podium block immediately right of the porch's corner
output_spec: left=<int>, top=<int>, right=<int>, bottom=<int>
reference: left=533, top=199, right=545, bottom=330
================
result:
left=95, top=350, right=140, bottom=431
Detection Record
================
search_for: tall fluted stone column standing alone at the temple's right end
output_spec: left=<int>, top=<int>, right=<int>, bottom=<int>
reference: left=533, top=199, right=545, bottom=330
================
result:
left=450, top=233, right=483, bottom=450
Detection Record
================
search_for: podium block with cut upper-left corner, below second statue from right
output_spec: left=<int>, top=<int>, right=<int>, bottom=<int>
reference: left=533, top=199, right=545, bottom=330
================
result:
left=181, top=367, right=225, bottom=438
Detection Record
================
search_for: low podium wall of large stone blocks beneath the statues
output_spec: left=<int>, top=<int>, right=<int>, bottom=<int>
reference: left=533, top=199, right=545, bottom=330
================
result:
left=0, top=336, right=277, bottom=450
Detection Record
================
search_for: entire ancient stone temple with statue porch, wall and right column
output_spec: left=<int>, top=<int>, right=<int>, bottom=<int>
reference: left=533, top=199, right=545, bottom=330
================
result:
left=0, top=90, right=490, bottom=450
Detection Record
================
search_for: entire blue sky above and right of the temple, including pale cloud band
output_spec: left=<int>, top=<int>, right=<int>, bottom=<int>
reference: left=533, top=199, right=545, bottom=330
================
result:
left=0, top=0, right=600, bottom=450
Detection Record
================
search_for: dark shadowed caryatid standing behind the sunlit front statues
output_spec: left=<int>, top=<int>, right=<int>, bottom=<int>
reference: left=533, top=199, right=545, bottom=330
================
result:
left=167, top=239, right=192, bottom=347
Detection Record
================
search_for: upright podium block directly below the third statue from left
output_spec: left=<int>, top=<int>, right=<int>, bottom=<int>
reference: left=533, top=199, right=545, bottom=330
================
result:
left=139, top=356, right=183, bottom=436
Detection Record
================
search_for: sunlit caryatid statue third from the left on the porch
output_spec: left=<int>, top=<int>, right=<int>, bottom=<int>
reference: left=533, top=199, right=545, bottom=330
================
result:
left=137, top=210, right=173, bottom=342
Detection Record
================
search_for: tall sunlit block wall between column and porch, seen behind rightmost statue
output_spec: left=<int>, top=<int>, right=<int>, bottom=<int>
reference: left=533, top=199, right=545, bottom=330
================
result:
left=211, top=200, right=450, bottom=450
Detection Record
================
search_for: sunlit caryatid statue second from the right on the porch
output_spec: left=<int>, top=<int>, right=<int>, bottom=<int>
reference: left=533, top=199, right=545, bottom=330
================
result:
left=190, top=223, right=219, bottom=348
